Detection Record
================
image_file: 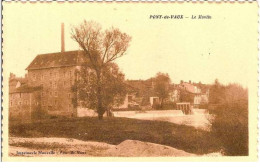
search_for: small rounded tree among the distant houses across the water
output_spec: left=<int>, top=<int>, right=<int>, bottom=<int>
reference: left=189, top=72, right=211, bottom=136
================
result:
left=154, top=72, right=171, bottom=108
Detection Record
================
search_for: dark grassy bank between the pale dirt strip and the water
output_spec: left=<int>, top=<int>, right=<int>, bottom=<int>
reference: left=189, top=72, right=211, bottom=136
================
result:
left=9, top=117, right=220, bottom=154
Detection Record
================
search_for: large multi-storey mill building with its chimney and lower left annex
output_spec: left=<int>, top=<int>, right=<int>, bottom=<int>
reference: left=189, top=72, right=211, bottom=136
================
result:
left=9, top=23, right=93, bottom=119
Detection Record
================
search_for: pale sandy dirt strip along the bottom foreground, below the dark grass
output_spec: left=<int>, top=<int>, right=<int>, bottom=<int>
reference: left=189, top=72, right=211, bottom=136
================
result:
left=9, top=137, right=198, bottom=157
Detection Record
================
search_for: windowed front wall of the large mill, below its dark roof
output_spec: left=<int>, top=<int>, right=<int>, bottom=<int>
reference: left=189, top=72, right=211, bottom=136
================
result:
left=28, top=66, right=76, bottom=116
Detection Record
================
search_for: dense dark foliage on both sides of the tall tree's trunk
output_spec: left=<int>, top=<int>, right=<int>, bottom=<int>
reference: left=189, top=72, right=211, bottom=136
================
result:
left=72, top=63, right=127, bottom=118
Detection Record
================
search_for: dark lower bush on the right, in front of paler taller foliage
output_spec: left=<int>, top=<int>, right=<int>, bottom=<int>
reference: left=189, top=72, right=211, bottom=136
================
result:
left=212, top=104, right=248, bottom=156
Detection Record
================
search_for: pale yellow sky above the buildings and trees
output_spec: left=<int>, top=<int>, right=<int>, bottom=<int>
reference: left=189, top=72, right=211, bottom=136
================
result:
left=3, top=3, right=257, bottom=86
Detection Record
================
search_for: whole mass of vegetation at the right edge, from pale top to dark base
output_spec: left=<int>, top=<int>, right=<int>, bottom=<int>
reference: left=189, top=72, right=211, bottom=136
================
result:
left=209, top=80, right=248, bottom=156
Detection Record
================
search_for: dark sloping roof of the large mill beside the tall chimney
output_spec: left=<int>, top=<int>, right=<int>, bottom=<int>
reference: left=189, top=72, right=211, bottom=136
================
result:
left=26, top=50, right=89, bottom=70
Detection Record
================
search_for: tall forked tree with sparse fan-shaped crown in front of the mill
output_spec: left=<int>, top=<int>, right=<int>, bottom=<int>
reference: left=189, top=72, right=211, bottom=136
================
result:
left=71, top=20, right=131, bottom=119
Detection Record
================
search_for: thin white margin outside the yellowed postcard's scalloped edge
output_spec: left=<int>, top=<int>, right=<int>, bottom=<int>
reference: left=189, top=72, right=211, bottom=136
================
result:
left=0, top=0, right=260, bottom=168
